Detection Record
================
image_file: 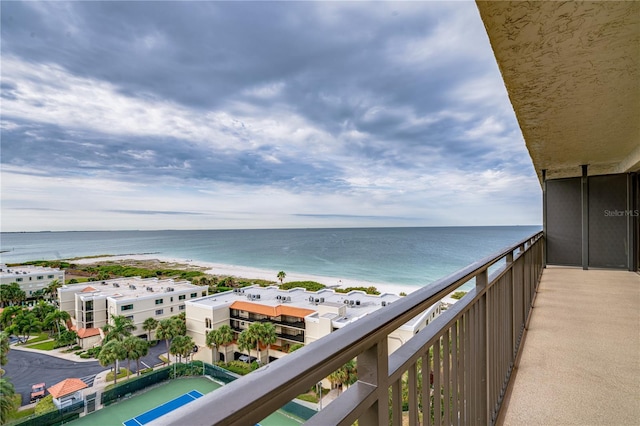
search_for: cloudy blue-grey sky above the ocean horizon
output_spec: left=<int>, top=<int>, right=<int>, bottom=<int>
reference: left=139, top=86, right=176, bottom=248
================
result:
left=1, top=1, right=541, bottom=231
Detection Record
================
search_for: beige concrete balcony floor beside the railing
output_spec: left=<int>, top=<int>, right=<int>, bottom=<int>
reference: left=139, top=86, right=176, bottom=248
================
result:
left=498, top=267, right=640, bottom=425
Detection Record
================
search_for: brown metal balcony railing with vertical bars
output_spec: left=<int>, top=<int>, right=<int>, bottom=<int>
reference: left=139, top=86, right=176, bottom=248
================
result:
left=153, top=233, right=544, bottom=426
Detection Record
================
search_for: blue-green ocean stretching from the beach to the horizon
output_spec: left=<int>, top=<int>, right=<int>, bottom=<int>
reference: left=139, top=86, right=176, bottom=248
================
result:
left=0, top=226, right=541, bottom=286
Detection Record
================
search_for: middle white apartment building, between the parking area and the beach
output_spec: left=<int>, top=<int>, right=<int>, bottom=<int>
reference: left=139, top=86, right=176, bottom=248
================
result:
left=58, top=277, right=207, bottom=349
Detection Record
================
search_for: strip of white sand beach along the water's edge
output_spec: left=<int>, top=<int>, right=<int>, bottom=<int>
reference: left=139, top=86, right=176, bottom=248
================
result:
left=73, top=254, right=455, bottom=303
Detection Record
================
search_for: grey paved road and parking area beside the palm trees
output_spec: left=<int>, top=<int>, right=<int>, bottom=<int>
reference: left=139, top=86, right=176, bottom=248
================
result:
left=3, top=342, right=166, bottom=405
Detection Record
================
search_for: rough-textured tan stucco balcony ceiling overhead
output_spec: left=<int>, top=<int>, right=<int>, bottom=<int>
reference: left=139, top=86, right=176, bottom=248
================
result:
left=477, top=1, right=640, bottom=178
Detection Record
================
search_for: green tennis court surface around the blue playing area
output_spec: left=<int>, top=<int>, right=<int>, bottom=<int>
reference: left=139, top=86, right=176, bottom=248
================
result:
left=68, top=377, right=303, bottom=426
